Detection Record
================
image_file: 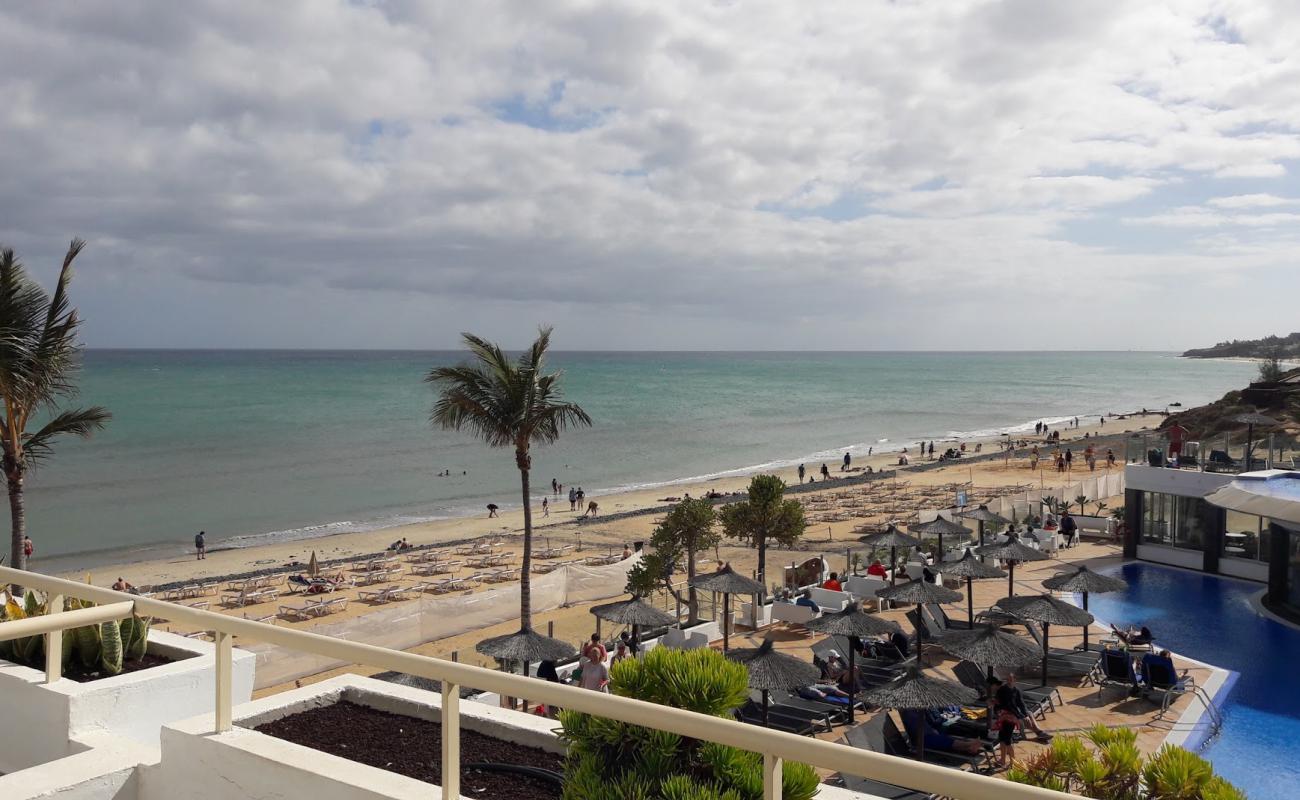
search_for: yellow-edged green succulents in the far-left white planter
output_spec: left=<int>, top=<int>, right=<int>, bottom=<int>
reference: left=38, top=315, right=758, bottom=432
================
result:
left=0, top=591, right=151, bottom=676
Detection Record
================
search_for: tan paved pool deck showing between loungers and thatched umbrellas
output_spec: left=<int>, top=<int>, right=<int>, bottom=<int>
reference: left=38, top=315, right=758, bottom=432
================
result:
left=732, top=541, right=1232, bottom=775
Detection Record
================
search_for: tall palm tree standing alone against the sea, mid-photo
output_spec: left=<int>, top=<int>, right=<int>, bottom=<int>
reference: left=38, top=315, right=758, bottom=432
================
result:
left=425, top=328, right=592, bottom=631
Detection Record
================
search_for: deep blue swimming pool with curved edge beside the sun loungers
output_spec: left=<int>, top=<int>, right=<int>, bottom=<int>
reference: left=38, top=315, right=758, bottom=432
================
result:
left=1088, top=563, right=1300, bottom=800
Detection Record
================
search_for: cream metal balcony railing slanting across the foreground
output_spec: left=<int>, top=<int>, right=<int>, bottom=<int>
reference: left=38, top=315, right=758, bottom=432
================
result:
left=0, top=567, right=1071, bottom=800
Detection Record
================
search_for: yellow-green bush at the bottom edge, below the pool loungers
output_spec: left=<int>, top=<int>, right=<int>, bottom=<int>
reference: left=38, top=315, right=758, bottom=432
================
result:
left=1006, top=725, right=1245, bottom=800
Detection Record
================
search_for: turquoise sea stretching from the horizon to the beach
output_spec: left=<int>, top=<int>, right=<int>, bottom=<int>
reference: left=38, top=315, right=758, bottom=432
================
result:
left=27, top=350, right=1255, bottom=570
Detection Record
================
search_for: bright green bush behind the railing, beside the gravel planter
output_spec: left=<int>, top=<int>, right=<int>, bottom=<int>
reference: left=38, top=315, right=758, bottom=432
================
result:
left=560, top=648, right=819, bottom=800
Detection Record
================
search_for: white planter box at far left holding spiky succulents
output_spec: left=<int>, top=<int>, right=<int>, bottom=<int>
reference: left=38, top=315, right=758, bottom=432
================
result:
left=0, top=631, right=255, bottom=773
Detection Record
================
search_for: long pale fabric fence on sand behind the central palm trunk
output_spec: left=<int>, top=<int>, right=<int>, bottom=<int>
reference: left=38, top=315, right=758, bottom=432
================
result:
left=241, top=553, right=641, bottom=689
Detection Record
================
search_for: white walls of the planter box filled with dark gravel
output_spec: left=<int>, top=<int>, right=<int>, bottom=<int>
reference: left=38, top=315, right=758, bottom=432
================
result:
left=139, top=675, right=564, bottom=800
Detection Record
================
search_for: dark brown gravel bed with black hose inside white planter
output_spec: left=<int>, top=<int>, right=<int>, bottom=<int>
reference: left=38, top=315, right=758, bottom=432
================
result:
left=254, top=700, right=564, bottom=800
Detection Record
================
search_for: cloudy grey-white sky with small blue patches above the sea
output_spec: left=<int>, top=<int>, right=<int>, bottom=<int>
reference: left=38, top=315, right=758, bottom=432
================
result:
left=0, top=0, right=1300, bottom=350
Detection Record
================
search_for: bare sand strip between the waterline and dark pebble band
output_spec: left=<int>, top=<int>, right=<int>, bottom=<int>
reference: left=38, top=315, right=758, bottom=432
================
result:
left=58, top=411, right=1164, bottom=587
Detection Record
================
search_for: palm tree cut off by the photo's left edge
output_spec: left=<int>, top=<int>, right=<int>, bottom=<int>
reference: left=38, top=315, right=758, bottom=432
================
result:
left=0, top=239, right=111, bottom=570
